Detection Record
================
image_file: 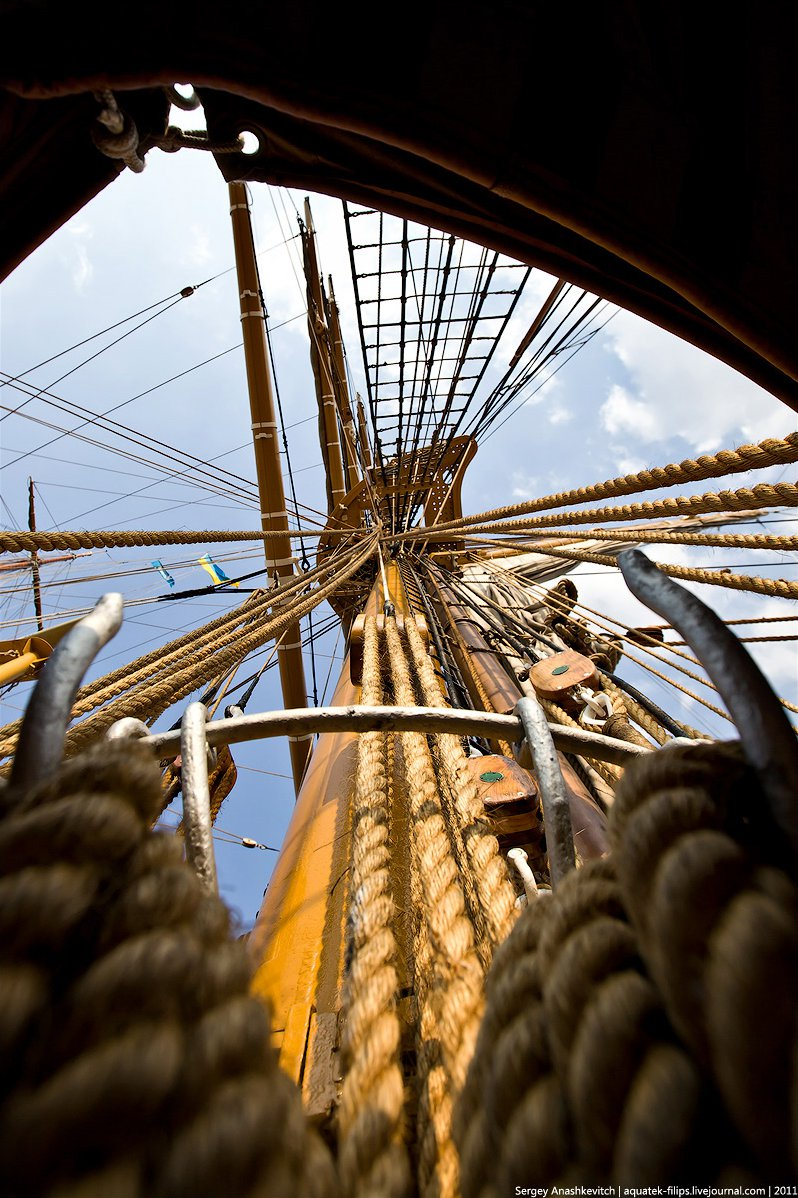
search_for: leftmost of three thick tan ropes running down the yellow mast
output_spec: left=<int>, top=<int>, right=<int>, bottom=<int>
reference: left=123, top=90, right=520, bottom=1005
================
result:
left=338, top=616, right=410, bottom=1198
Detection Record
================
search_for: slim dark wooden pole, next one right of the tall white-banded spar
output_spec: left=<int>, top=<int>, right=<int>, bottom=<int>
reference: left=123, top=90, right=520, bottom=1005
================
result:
left=300, top=199, right=346, bottom=512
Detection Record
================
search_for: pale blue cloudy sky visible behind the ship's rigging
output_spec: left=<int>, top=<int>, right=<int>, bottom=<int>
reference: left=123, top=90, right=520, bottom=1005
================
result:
left=0, top=105, right=798, bottom=926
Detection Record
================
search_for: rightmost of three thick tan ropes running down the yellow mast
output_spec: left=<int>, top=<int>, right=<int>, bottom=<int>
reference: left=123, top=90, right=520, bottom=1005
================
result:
left=405, top=619, right=515, bottom=945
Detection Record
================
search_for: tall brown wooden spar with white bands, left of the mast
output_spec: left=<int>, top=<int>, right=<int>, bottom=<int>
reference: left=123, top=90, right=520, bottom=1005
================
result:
left=229, top=183, right=313, bottom=793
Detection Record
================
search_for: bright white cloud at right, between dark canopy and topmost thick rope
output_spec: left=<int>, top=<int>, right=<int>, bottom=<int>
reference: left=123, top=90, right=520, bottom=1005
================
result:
left=600, top=313, right=796, bottom=453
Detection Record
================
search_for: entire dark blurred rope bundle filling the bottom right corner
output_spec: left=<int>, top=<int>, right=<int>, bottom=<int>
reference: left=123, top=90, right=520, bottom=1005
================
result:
left=455, top=745, right=798, bottom=1183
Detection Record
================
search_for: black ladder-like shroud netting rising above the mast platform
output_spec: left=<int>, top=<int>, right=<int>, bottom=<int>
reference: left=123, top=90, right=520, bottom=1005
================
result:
left=344, top=204, right=601, bottom=532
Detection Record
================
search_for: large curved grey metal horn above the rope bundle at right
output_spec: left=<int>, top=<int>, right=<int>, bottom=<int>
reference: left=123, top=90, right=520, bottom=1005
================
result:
left=617, top=549, right=798, bottom=853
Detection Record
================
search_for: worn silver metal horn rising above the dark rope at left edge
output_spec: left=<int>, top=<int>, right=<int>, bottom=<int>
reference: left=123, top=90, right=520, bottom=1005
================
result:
left=11, top=592, right=122, bottom=787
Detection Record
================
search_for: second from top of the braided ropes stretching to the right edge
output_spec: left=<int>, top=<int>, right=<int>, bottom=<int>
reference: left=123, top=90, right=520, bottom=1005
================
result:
left=400, top=483, right=798, bottom=549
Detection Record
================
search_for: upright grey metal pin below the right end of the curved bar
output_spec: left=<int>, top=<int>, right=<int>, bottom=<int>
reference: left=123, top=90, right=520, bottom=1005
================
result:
left=514, top=696, right=576, bottom=889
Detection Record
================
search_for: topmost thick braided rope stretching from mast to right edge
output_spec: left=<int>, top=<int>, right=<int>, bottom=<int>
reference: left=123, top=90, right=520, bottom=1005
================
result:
left=390, top=432, right=798, bottom=532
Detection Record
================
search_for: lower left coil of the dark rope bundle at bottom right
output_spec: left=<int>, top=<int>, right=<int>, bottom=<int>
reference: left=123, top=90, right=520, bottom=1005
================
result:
left=455, top=861, right=752, bottom=1198
